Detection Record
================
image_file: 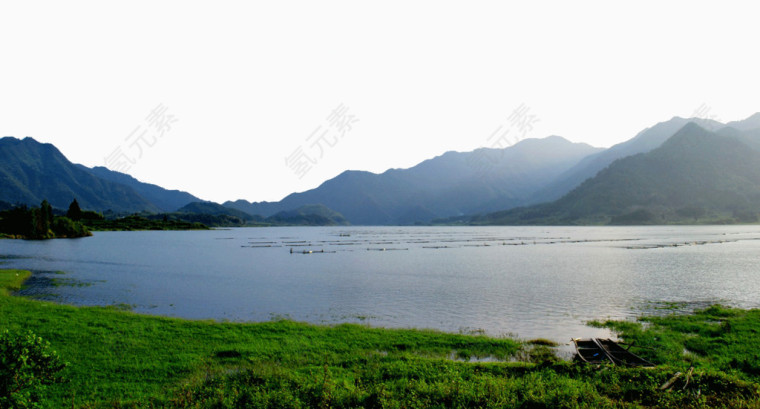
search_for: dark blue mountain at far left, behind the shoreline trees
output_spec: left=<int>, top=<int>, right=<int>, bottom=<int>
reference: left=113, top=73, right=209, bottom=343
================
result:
left=0, top=137, right=199, bottom=212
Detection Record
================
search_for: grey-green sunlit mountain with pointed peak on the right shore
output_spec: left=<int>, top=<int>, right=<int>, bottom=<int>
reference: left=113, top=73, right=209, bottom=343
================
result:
left=473, top=122, right=760, bottom=224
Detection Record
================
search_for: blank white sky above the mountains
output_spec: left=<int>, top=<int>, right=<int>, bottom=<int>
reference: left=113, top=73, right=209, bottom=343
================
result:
left=0, top=1, right=760, bottom=202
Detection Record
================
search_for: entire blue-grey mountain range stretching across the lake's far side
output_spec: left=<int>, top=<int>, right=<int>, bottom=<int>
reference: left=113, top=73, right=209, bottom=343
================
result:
left=0, top=113, right=760, bottom=225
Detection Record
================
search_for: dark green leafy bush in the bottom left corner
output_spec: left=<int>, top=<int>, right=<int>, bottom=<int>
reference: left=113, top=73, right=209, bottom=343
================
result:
left=0, top=330, right=66, bottom=408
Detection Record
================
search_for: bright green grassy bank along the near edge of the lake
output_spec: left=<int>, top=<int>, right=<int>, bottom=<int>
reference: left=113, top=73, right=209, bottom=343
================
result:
left=0, top=270, right=760, bottom=408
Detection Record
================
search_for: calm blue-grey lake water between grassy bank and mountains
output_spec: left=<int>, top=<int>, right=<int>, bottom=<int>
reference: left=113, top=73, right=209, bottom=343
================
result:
left=0, top=226, right=760, bottom=342
